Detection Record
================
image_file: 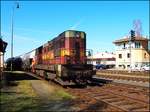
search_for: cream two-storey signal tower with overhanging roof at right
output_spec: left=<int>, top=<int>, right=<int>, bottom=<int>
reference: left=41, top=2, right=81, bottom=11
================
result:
left=113, top=36, right=150, bottom=70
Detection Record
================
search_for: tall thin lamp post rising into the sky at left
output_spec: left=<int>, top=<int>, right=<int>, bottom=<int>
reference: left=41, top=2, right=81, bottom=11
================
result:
left=11, top=2, right=19, bottom=71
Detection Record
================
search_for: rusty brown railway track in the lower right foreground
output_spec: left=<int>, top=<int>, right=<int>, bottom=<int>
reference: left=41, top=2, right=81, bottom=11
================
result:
left=67, top=84, right=149, bottom=112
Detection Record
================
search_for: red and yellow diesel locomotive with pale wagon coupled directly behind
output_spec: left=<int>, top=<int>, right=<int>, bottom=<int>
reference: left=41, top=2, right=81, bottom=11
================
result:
left=21, top=30, right=96, bottom=85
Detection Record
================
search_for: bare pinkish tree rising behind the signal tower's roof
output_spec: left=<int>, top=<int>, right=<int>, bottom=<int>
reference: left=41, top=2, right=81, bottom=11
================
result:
left=133, top=19, right=142, bottom=37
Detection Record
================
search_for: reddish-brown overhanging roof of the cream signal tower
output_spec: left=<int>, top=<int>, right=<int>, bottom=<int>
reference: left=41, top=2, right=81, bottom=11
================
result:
left=113, top=37, right=149, bottom=44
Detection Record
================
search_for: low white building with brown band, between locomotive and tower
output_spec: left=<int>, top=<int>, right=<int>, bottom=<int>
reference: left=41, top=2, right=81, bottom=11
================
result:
left=87, top=51, right=115, bottom=67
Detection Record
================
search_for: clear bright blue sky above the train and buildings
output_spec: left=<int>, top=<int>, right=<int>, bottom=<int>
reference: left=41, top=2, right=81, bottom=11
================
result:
left=1, top=1, right=149, bottom=59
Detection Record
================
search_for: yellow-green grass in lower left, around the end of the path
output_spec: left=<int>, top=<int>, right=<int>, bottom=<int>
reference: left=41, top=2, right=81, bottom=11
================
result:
left=0, top=80, right=75, bottom=112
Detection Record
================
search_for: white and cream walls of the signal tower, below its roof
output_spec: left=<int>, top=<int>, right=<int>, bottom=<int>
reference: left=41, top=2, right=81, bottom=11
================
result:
left=116, top=42, right=150, bottom=69
